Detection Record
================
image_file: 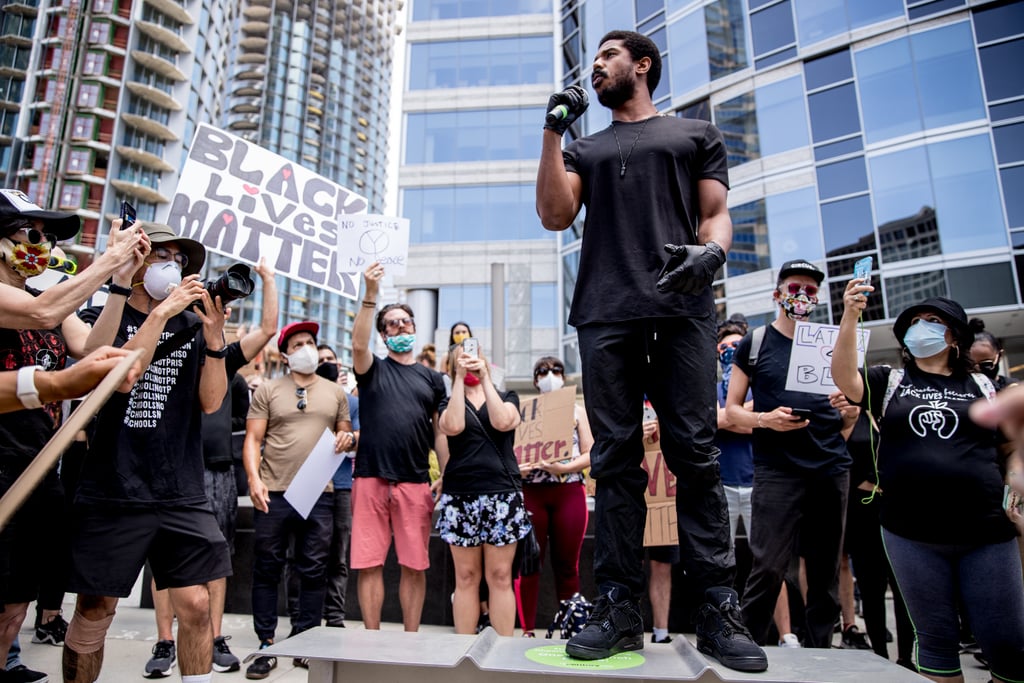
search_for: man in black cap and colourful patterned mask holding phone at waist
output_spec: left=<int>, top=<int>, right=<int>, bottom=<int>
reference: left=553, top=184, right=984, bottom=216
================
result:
left=725, top=260, right=859, bottom=647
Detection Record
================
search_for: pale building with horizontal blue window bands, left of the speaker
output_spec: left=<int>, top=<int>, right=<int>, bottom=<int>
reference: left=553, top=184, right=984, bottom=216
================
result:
left=394, top=0, right=560, bottom=380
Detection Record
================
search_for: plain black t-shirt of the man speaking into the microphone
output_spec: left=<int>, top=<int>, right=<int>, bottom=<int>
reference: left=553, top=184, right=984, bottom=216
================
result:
left=562, top=116, right=729, bottom=327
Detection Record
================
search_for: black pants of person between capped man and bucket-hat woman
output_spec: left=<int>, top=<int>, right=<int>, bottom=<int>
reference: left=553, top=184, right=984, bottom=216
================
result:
left=846, top=487, right=913, bottom=661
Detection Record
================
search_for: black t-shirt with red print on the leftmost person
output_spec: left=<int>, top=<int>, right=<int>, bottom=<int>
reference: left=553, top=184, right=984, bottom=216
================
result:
left=0, top=287, right=68, bottom=481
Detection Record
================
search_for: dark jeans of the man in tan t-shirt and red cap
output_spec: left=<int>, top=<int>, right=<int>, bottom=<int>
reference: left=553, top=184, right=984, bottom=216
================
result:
left=253, top=492, right=334, bottom=641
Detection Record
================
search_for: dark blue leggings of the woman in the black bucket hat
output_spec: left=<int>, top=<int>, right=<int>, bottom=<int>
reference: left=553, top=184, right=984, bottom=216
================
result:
left=882, top=529, right=1024, bottom=681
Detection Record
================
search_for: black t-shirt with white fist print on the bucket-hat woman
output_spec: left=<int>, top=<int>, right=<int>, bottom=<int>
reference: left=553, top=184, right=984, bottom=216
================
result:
left=864, top=366, right=1016, bottom=544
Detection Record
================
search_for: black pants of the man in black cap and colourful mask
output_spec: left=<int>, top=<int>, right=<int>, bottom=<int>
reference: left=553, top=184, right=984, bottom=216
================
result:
left=743, top=465, right=850, bottom=647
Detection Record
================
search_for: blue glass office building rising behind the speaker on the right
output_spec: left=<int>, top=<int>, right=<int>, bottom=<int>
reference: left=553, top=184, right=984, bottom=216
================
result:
left=559, top=0, right=1024, bottom=365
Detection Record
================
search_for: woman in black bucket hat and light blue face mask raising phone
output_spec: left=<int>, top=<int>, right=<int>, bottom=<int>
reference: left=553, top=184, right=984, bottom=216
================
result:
left=831, top=280, right=1024, bottom=681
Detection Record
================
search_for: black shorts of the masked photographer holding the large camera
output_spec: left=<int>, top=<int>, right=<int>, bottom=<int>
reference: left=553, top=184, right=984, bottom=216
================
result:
left=68, top=504, right=231, bottom=598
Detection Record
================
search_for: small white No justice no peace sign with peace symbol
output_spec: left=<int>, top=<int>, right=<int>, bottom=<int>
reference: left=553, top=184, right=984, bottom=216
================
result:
left=338, top=214, right=409, bottom=275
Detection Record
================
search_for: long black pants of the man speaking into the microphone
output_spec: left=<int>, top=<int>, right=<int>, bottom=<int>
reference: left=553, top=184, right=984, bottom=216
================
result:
left=579, top=317, right=735, bottom=599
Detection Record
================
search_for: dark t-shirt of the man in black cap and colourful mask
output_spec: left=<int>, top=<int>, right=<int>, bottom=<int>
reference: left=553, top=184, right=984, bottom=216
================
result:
left=733, top=325, right=851, bottom=474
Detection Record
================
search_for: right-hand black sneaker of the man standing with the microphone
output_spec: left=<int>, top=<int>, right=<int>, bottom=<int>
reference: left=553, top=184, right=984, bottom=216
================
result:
left=696, top=586, right=768, bottom=673
